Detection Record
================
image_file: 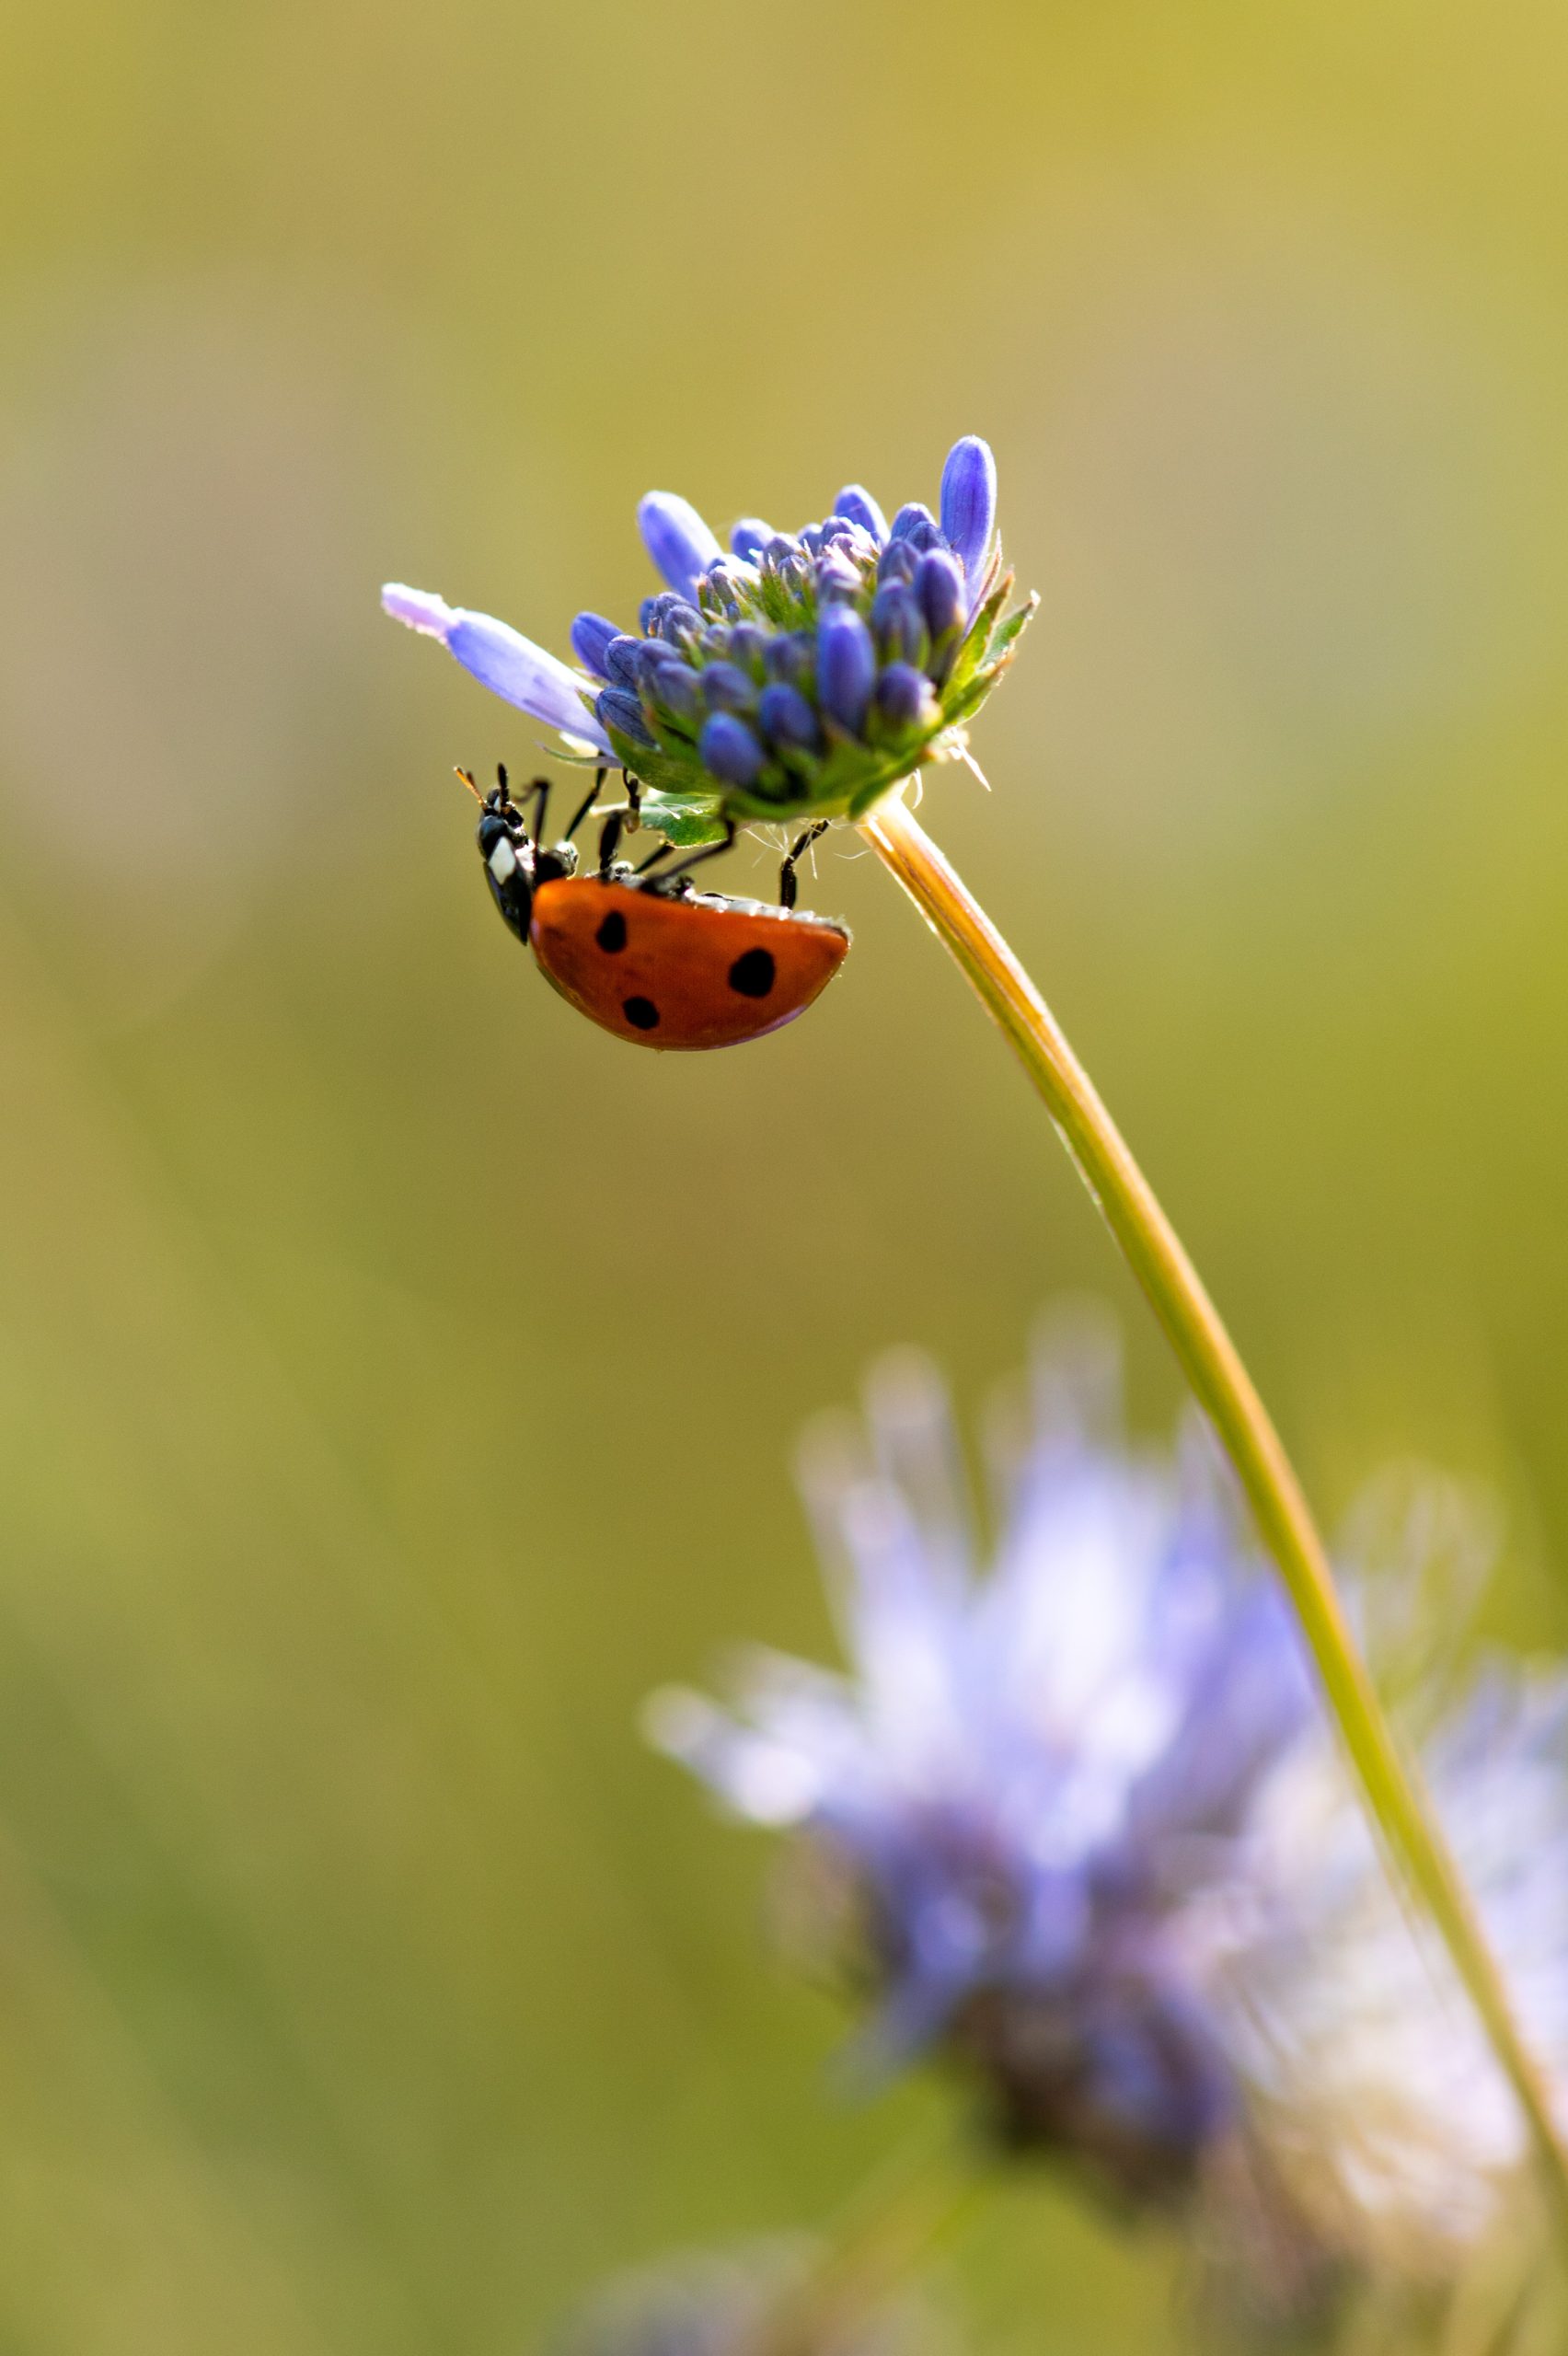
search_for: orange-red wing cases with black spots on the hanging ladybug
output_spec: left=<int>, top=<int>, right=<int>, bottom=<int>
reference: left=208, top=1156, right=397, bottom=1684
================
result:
left=527, top=876, right=850, bottom=1051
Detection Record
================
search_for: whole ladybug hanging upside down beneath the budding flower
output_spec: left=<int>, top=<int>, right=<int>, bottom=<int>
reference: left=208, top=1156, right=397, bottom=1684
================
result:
left=456, top=768, right=850, bottom=1051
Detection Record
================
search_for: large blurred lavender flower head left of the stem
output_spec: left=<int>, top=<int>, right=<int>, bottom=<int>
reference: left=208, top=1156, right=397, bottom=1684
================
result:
left=650, top=1336, right=1311, bottom=2200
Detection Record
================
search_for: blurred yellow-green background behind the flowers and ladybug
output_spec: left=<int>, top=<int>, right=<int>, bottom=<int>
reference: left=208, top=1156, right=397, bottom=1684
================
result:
left=0, top=0, right=1568, bottom=2356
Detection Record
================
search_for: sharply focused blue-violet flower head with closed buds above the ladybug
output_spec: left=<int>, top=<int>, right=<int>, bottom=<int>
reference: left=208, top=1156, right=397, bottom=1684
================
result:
left=381, top=436, right=1036, bottom=843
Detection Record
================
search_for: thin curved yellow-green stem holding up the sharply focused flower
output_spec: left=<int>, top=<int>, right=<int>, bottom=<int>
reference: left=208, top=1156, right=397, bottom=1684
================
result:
left=859, top=796, right=1568, bottom=2231
